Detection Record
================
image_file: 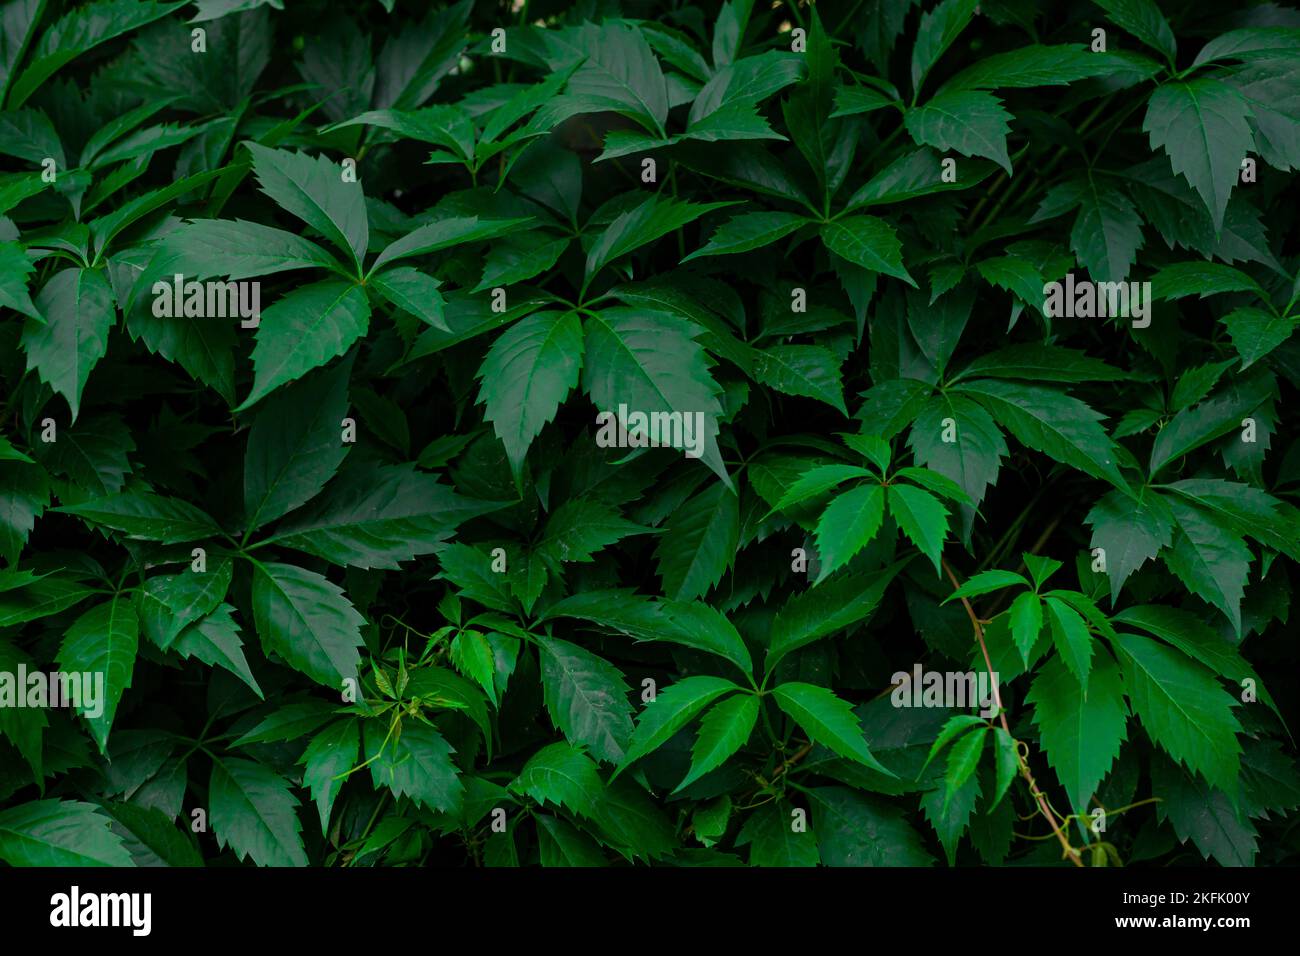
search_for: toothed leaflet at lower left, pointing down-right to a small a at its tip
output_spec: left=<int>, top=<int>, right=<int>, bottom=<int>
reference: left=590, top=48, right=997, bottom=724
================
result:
left=252, top=562, right=364, bottom=691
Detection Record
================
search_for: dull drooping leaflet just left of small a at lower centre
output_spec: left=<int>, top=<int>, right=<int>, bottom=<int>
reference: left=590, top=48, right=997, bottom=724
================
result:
left=541, top=637, right=632, bottom=763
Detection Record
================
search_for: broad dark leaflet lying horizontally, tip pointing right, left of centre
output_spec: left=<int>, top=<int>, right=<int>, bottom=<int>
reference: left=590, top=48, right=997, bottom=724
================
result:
left=269, top=464, right=502, bottom=568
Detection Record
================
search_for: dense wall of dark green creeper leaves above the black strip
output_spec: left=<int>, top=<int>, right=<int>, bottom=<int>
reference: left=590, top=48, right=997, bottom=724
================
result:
left=0, top=0, right=1300, bottom=866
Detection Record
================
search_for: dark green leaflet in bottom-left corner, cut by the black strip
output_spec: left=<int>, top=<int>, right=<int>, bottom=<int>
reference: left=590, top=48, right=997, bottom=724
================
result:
left=0, top=800, right=133, bottom=866
